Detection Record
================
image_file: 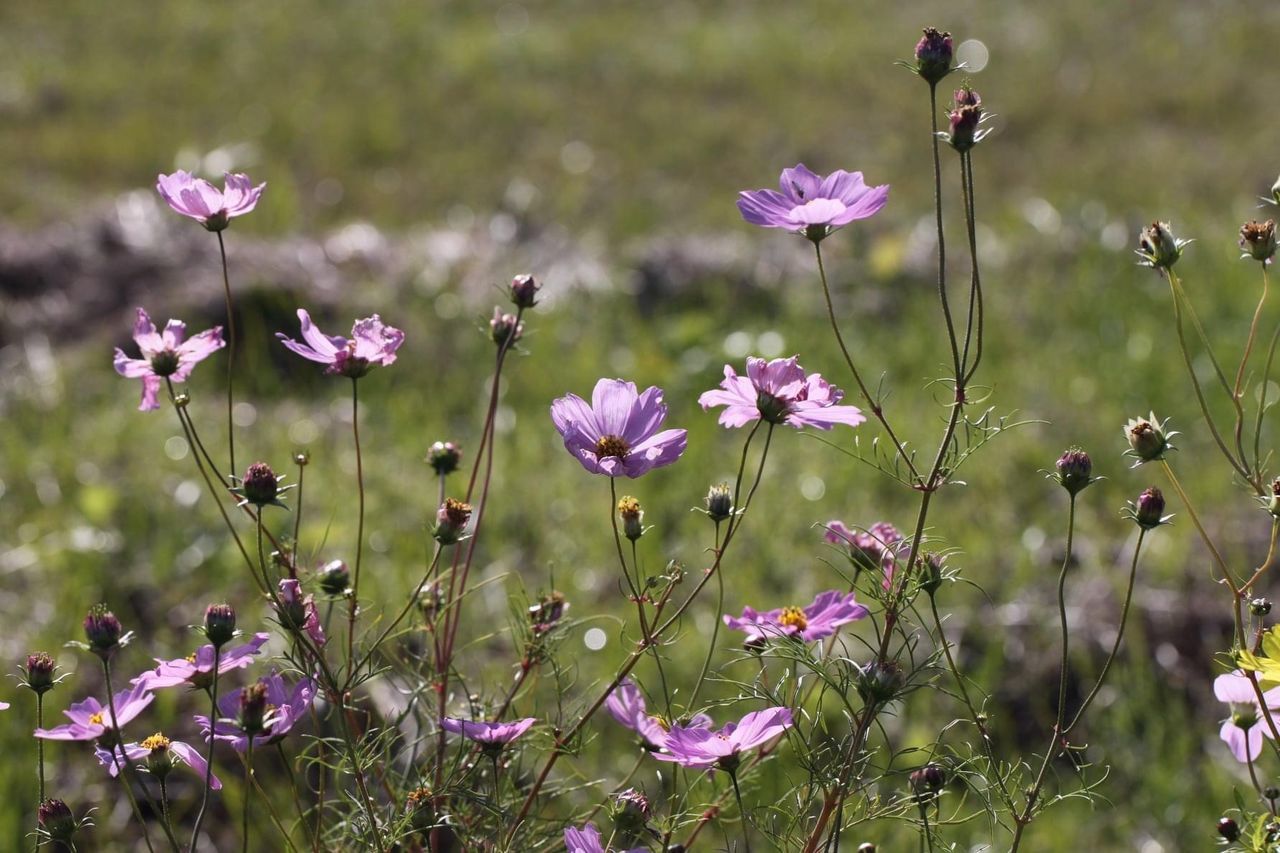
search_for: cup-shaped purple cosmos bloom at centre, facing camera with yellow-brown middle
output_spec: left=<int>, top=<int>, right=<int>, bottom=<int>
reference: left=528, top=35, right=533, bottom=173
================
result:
left=552, top=379, right=689, bottom=478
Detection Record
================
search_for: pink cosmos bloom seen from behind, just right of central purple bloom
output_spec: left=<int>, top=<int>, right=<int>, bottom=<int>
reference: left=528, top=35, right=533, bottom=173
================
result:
left=698, top=356, right=867, bottom=429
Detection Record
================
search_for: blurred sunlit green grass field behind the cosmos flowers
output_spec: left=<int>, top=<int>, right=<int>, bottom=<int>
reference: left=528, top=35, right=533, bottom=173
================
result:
left=0, top=0, right=1280, bottom=852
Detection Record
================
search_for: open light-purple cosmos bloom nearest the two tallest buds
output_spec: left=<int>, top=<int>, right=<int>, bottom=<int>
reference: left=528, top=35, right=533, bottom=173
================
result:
left=737, top=163, right=888, bottom=242
